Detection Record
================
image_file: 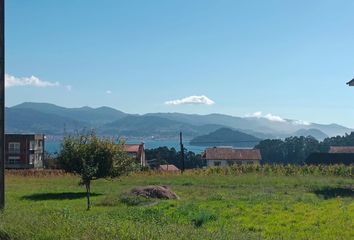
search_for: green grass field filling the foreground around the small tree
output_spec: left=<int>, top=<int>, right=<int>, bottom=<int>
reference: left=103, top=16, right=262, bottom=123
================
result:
left=0, top=173, right=354, bottom=239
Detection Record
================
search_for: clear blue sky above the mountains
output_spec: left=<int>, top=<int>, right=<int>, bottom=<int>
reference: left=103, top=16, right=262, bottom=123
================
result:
left=5, top=0, right=354, bottom=127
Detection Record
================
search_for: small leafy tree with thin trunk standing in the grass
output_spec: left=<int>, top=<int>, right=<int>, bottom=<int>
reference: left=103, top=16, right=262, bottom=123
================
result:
left=58, top=131, right=133, bottom=210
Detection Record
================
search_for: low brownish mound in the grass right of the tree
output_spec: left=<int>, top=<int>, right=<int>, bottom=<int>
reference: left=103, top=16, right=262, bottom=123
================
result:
left=131, top=186, right=179, bottom=199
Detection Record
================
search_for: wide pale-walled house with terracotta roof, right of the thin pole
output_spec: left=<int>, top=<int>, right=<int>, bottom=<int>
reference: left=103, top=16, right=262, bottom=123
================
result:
left=203, top=147, right=262, bottom=167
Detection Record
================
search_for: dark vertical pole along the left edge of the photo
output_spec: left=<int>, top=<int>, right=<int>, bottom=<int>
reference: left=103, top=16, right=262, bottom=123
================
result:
left=0, top=0, right=5, bottom=210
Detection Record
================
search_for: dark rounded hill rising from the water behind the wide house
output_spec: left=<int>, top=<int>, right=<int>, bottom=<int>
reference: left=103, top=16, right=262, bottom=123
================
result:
left=190, top=128, right=261, bottom=147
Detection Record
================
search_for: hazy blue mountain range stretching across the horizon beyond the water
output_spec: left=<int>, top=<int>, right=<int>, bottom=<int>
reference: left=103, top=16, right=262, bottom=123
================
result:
left=5, top=102, right=353, bottom=140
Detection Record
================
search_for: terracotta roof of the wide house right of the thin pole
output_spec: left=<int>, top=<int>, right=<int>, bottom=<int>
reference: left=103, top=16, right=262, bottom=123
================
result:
left=203, top=148, right=261, bottom=160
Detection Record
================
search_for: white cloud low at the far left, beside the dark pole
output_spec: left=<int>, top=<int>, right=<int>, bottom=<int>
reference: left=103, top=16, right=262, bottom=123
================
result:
left=5, top=74, right=60, bottom=88
